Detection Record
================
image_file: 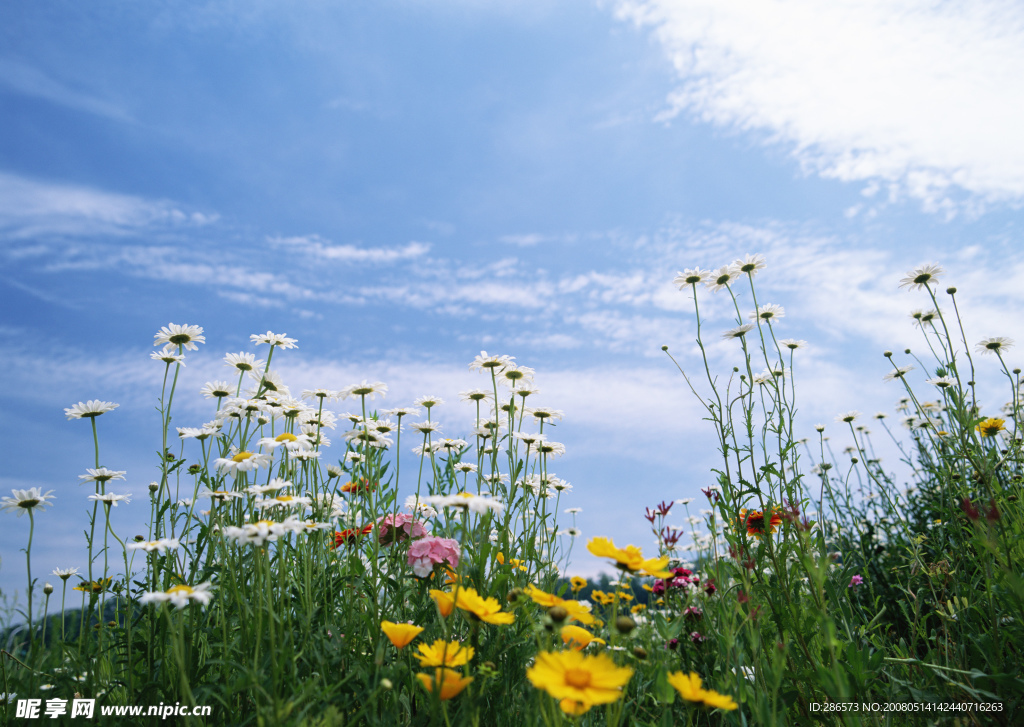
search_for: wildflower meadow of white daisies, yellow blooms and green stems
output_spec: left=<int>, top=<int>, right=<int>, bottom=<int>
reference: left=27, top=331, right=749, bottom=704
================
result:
left=0, top=255, right=1024, bottom=727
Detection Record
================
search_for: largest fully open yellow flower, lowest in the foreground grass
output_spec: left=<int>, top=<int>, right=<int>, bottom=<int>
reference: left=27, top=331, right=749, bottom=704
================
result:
left=526, top=651, right=633, bottom=715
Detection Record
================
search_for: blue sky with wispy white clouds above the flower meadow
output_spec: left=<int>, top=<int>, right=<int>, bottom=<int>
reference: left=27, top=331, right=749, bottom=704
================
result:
left=0, top=0, right=1024, bottom=594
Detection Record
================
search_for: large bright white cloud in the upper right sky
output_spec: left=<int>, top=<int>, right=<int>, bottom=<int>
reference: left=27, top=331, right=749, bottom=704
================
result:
left=617, top=0, right=1024, bottom=213
